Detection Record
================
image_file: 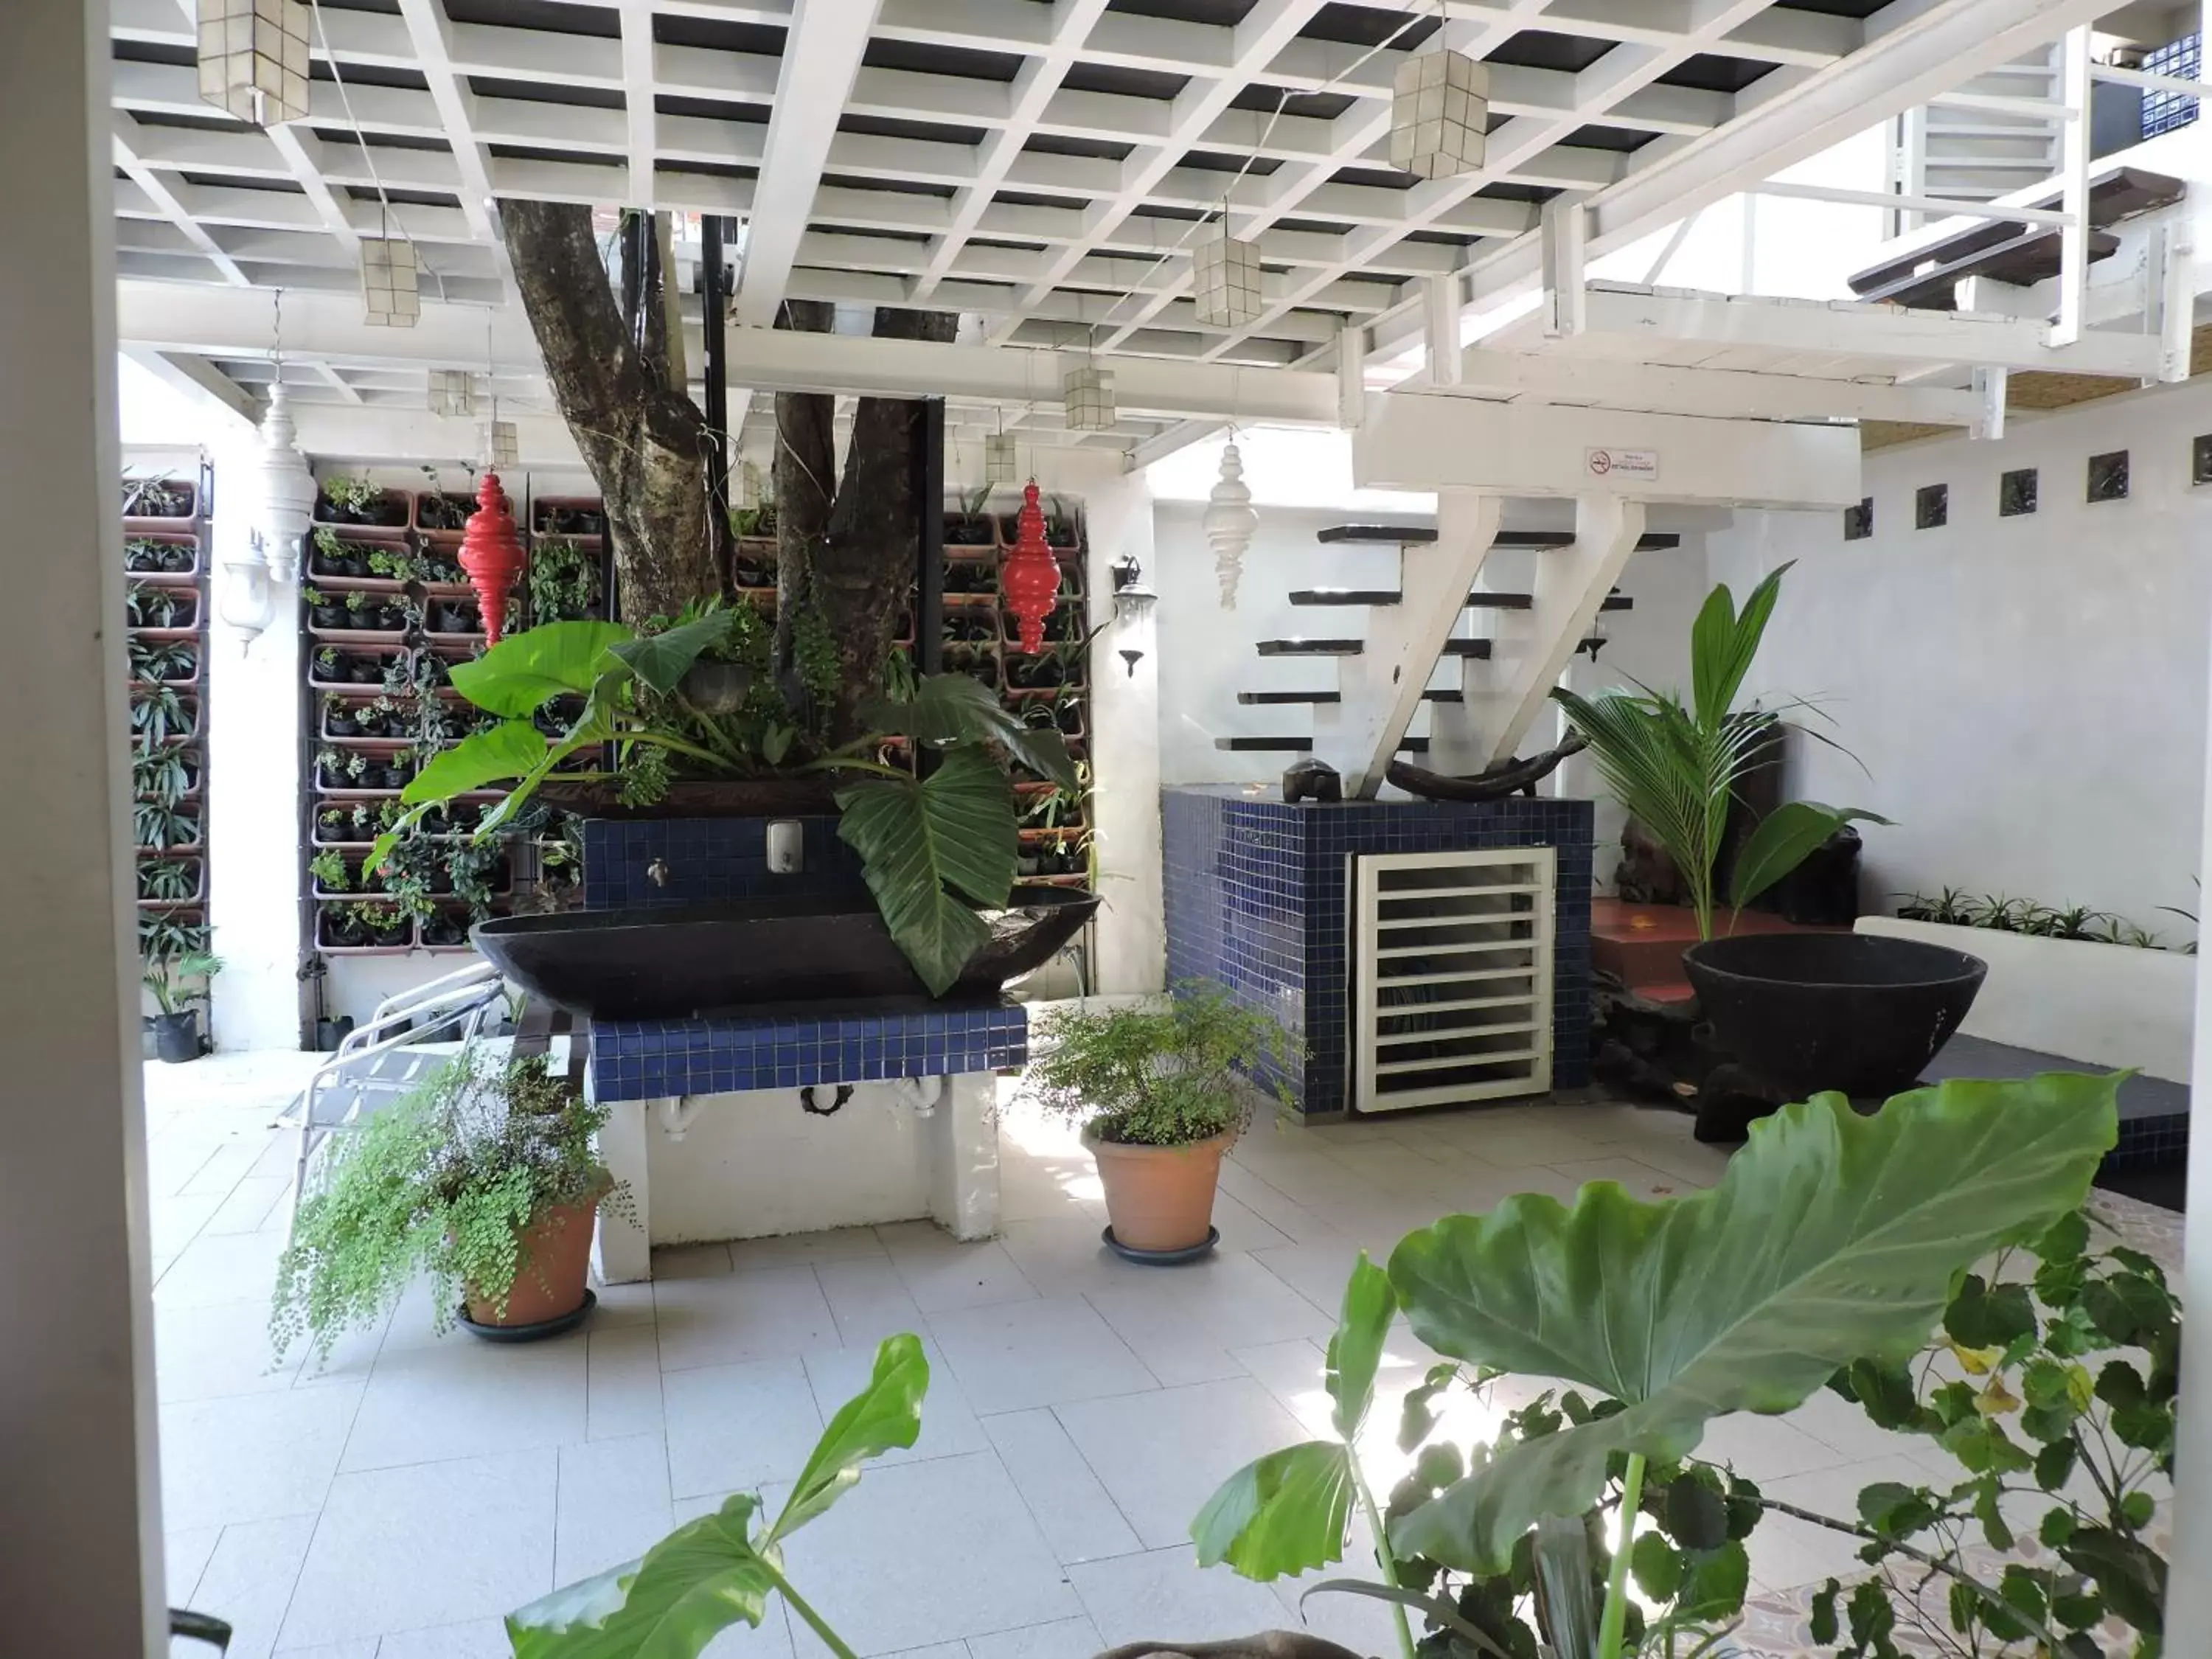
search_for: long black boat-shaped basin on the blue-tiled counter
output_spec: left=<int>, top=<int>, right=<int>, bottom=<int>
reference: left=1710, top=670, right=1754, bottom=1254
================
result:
left=484, top=887, right=1099, bottom=1020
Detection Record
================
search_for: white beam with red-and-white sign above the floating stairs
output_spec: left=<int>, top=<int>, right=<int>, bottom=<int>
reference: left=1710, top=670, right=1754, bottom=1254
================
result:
left=1352, top=392, right=1863, bottom=509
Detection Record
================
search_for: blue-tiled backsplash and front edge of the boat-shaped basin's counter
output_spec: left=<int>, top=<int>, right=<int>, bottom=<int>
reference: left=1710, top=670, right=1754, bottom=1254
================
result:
left=584, top=816, right=1029, bottom=1102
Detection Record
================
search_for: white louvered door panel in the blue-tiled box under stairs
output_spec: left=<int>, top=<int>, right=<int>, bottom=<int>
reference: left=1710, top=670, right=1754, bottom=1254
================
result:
left=1347, top=847, right=1559, bottom=1113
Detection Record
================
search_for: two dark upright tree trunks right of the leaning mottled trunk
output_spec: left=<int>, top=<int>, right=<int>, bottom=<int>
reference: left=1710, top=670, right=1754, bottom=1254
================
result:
left=776, top=301, right=958, bottom=743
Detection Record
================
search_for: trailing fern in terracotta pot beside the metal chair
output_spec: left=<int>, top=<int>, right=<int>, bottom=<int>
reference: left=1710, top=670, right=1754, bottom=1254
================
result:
left=270, top=1044, right=628, bottom=1356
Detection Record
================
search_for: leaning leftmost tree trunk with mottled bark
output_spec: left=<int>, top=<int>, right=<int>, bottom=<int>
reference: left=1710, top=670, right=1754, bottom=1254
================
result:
left=500, top=201, right=719, bottom=624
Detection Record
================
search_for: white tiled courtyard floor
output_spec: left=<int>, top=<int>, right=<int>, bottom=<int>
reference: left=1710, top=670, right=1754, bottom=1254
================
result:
left=150, top=1055, right=2168, bottom=1659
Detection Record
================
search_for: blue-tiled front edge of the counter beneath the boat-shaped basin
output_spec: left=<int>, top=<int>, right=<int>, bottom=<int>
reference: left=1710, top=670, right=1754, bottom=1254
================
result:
left=591, top=1004, right=1029, bottom=1102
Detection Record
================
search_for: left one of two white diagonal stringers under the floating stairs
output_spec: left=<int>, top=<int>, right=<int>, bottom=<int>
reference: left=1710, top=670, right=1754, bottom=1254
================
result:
left=1314, top=489, right=1504, bottom=801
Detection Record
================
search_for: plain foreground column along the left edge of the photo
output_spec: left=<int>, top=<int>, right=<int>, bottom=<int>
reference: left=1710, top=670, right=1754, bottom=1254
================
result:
left=0, top=0, right=168, bottom=1655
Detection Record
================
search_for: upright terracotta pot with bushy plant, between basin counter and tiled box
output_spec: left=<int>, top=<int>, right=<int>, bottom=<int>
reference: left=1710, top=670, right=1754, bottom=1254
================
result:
left=1024, top=980, right=1301, bottom=1261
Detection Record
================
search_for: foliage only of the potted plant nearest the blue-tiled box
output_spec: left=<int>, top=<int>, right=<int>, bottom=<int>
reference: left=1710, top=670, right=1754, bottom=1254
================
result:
left=1022, top=980, right=1303, bottom=1146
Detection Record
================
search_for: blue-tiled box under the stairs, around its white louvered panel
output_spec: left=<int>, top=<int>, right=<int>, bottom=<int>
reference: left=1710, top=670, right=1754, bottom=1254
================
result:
left=1161, top=785, right=1593, bottom=1113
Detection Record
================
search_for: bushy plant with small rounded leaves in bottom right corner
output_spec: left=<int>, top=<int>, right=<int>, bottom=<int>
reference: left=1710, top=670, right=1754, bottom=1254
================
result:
left=1820, top=1210, right=2181, bottom=1659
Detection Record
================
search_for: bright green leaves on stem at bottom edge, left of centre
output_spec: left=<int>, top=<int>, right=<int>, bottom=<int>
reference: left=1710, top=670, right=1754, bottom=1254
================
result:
left=507, top=1334, right=929, bottom=1659
